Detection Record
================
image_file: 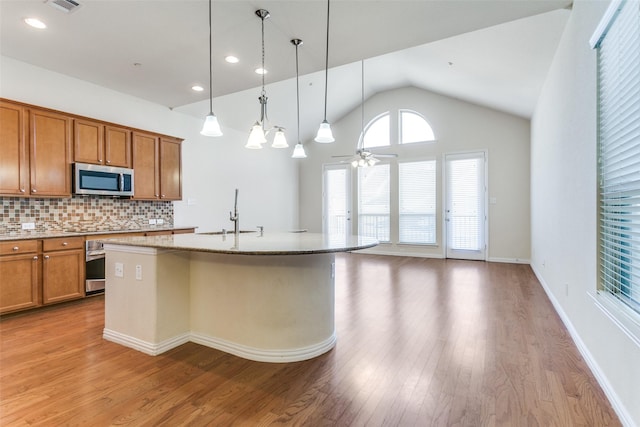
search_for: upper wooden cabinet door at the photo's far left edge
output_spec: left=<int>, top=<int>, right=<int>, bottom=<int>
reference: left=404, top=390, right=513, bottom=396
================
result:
left=0, top=101, right=30, bottom=196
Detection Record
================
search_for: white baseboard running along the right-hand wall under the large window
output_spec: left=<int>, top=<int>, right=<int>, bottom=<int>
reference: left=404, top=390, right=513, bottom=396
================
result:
left=531, top=264, right=635, bottom=427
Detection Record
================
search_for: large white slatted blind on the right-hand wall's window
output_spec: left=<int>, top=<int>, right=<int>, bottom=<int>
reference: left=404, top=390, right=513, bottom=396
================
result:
left=596, top=1, right=640, bottom=313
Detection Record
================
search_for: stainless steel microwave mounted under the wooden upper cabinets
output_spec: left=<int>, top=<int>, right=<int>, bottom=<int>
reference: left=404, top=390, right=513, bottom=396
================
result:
left=73, top=163, right=133, bottom=197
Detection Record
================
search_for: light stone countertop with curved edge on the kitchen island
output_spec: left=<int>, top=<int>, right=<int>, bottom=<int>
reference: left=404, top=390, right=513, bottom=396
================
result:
left=102, top=232, right=378, bottom=255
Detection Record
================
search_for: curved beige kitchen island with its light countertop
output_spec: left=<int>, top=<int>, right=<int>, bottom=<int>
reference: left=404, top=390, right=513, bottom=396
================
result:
left=103, top=232, right=378, bottom=362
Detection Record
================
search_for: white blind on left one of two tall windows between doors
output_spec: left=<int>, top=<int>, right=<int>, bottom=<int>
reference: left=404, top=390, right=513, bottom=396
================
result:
left=358, top=164, right=391, bottom=242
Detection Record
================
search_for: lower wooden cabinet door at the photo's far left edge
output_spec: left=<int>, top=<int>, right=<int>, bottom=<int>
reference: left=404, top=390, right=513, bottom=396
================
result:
left=0, top=253, right=40, bottom=313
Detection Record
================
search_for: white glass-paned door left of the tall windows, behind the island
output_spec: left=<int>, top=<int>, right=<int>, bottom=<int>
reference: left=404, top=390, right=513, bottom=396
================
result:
left=322, top=164, right=352, bottom=238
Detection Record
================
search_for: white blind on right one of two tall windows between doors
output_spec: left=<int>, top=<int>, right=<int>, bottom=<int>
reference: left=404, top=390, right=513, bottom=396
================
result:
left=398, top=160, right=436, bottom=244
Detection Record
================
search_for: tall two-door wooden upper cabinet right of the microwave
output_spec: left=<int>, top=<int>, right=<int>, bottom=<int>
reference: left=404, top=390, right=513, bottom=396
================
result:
left=132, top=131, right=182, bottom=200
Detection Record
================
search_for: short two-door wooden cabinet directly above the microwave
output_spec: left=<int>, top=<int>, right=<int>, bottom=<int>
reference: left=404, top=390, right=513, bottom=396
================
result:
left=73, top=119, right=131, bottom=168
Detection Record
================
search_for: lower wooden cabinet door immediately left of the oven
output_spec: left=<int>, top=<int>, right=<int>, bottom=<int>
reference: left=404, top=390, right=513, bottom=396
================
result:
left=42, top=250, right=85, bottom=304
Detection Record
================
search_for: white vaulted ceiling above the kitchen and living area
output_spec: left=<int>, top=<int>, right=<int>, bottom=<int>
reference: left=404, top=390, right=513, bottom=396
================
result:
left=0, top=0, right=571, bottom=137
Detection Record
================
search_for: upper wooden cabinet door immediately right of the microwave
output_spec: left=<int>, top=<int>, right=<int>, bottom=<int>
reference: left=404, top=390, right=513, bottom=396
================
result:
left=132, top=132, right=160, bottom=200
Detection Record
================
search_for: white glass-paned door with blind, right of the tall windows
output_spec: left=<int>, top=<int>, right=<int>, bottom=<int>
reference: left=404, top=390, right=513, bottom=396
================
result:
left=444, top=152, right=487, bottom=260
